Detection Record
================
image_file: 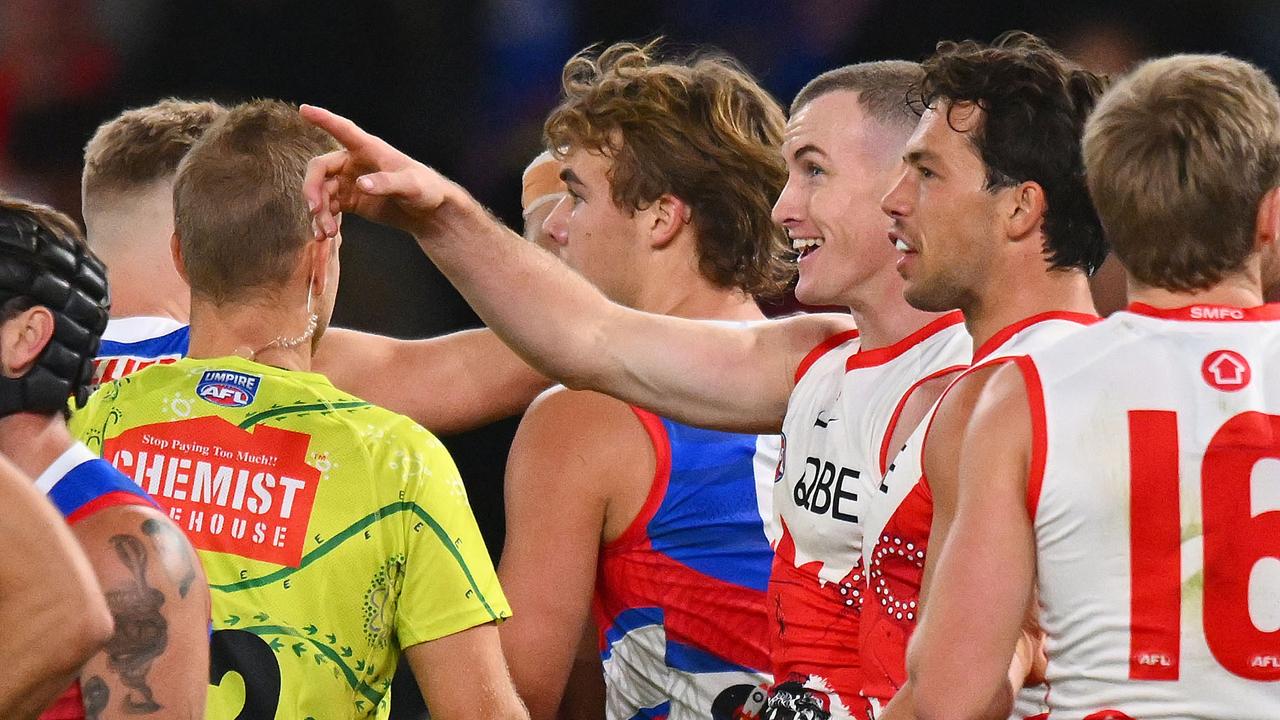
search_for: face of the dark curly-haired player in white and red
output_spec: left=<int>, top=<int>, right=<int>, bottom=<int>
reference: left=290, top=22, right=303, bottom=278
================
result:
left=882, top=102, right=1009, bottom=313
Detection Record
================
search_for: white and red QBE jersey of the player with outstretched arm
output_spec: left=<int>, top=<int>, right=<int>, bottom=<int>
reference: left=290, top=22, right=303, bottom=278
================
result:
left=769, top=313, right=972, bottom=720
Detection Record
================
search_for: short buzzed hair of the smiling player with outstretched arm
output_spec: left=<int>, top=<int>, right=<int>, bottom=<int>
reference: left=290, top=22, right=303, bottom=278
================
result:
left=791, top=60, right=924, bottom=131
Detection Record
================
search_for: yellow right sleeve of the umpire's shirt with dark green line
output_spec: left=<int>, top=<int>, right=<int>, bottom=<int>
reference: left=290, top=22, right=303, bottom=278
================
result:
left=396, top=428, right=511, bottom=647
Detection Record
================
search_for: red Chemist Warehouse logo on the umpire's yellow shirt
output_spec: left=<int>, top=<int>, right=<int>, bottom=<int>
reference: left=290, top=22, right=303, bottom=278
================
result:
left=102, top=415, right=320, bottom=568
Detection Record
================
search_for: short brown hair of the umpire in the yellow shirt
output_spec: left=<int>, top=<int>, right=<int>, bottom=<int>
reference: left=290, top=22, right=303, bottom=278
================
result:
left=173, top=100, right=338, bottom=305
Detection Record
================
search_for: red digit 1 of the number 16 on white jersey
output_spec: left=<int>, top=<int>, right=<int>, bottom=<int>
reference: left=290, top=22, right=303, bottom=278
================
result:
left=1129, top=410, right=1181, bottom=680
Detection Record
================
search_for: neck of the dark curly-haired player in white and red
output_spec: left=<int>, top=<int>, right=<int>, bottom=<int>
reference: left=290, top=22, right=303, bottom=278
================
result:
left=961, top=269, right=1097, bottom=348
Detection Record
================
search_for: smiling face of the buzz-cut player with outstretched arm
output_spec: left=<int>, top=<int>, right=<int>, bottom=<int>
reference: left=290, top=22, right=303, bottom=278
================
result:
left=773, top=90, right=905, bottom=305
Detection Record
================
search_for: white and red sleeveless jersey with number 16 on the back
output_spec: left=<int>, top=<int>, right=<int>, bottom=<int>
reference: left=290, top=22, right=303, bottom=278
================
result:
left=1018, top=299, right=1280, bottom=720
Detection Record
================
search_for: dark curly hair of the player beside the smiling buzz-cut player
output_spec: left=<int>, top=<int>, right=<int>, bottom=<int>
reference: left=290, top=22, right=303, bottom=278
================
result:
left=913, top=31, right=1107, bottom=274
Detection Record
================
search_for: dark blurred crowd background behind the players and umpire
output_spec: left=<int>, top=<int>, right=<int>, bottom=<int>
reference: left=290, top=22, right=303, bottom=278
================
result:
left=0, top=0, right=1280, bottom=717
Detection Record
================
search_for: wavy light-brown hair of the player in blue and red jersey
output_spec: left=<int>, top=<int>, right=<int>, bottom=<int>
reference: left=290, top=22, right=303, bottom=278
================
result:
left=544, top=41, right=795, bottom=297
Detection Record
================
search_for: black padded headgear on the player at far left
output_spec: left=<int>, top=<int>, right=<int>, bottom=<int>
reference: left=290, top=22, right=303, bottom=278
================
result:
left=0, top=206, right=110, bottom=418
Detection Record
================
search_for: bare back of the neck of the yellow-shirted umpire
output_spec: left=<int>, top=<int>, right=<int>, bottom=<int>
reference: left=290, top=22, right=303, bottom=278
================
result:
left=187, top=297, right=312, bottom=372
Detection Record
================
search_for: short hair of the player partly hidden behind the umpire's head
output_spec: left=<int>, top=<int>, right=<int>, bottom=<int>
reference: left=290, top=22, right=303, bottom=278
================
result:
left=81, top=97, right=227, bottom=205
